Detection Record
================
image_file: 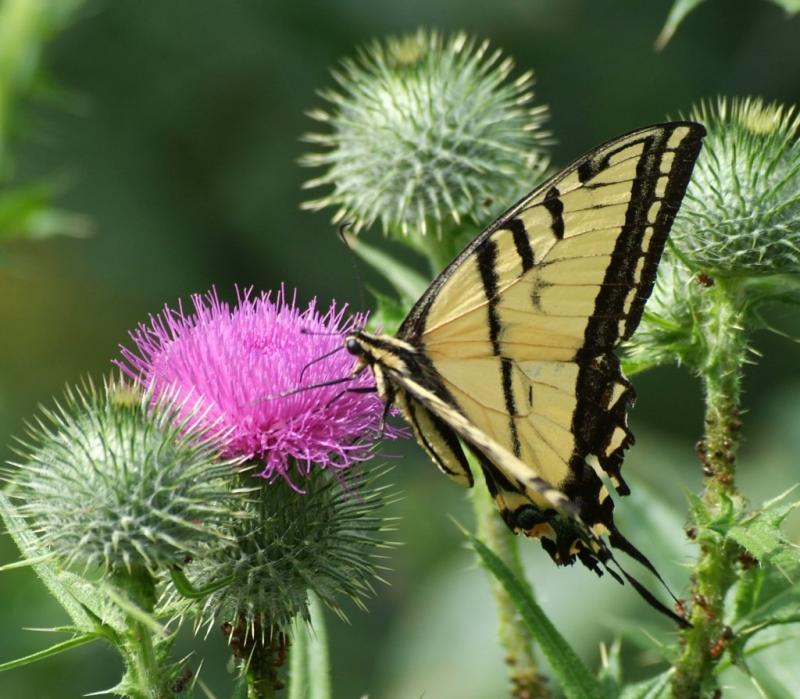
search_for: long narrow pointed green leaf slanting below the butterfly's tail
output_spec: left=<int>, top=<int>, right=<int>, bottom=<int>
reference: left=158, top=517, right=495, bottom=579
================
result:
left=465, top=532, right=607, bottom=699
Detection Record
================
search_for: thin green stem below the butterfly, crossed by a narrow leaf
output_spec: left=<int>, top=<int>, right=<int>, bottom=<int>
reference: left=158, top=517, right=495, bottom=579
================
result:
left=470, top=458, right=549, bottom=699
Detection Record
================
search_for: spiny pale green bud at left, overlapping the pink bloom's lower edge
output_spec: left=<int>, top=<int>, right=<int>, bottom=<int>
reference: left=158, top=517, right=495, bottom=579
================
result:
left=7, top=381, right=244, bottom=573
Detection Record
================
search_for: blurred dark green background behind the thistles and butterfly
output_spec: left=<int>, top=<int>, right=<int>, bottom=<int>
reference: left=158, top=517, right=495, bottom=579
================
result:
left=0, top=0, right=800, bottom=699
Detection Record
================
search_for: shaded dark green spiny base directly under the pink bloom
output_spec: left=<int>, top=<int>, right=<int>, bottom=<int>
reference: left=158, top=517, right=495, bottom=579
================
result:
left=164, top=467, right=392, bottom=638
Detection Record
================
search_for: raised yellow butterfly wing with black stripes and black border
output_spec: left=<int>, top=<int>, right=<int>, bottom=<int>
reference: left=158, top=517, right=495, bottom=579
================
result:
left=397, top=122, right=705, bottom=544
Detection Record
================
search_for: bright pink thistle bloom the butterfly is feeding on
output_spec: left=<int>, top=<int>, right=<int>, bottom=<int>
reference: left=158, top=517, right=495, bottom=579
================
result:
left=115, top=289, right=399, bottom=483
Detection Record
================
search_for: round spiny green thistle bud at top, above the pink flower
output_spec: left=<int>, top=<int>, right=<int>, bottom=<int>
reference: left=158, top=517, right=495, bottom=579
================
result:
left=301, top=30, right=549, bottom=235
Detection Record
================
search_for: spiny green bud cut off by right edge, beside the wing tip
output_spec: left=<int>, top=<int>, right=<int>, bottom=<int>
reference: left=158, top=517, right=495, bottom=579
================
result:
left=672, top=98, right=800, bottom=277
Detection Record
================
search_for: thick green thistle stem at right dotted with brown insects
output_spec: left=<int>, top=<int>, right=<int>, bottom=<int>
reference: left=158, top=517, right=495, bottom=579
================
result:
left=672, top=282, right=747, bottom=699
